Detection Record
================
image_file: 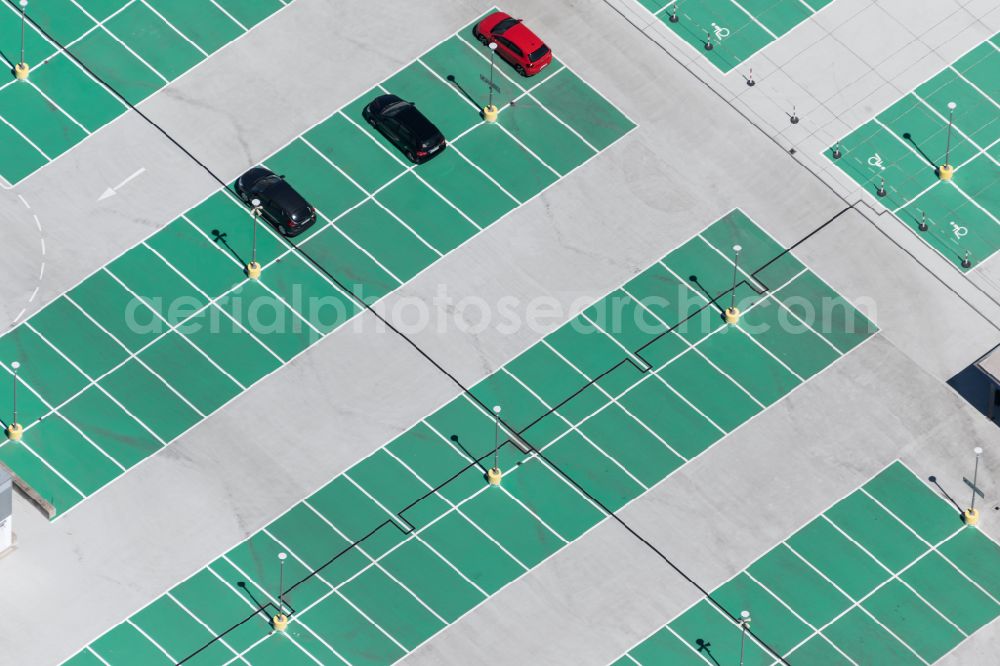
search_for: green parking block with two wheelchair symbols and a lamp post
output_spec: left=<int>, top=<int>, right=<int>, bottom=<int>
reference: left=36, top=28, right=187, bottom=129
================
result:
left=824, top=31, right=1000, bottom=271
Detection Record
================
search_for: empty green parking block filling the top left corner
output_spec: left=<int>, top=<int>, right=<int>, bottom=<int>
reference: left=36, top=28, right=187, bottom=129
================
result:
left=0, top=0, right=284, bottom=184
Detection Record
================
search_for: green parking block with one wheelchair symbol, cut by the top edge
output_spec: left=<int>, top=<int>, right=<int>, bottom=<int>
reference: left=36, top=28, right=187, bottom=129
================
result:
left=636, top=0, right=832, bottom=72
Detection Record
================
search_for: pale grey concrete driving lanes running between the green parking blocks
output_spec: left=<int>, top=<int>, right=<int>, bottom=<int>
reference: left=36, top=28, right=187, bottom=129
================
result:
left=0, top=0, right=1000, bottom=665
